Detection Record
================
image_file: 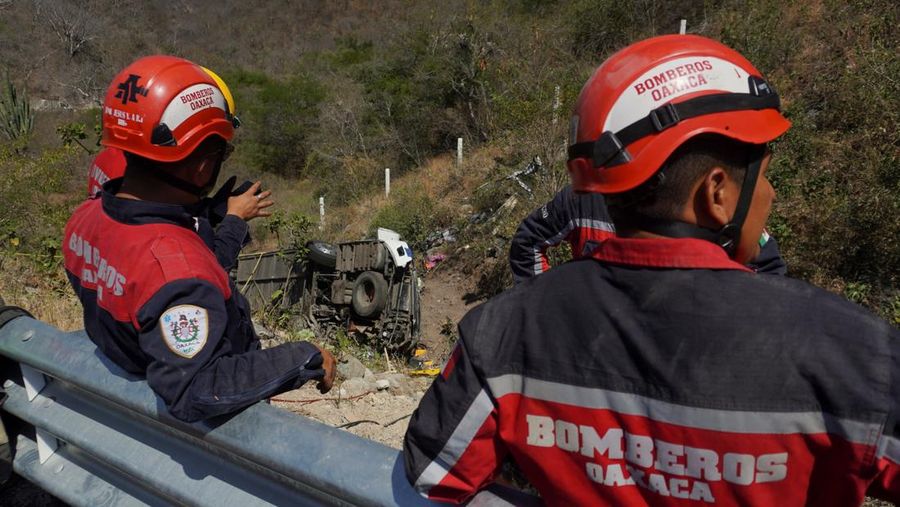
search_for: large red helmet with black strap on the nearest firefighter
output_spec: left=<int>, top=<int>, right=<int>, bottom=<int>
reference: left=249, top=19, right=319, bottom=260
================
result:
left=568, top=35, right=791, bottom=194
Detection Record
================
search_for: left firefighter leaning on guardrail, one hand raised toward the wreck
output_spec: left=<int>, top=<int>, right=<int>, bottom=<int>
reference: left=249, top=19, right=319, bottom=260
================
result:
left=62, top=56, right=334, bottom=421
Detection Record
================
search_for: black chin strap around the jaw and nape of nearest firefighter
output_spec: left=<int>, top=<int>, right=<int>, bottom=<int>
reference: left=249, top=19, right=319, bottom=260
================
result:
left=628, top=148, right=766, bottom=258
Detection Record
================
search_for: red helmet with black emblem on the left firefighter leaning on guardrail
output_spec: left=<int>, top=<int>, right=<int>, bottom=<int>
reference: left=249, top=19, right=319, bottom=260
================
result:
left=101, top=56, right=234, bottom=162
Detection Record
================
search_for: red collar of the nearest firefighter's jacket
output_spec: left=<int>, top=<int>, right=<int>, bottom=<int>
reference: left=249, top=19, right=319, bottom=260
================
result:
left=590, top=238, right=753, bottom=273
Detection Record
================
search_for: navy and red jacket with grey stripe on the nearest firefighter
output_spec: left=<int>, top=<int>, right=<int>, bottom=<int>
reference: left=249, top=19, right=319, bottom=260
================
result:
left=404, top=238, right=900, bottom=506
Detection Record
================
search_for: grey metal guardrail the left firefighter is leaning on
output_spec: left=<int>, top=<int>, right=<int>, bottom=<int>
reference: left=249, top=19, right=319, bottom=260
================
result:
left=0, top=316, right=534, bottom=507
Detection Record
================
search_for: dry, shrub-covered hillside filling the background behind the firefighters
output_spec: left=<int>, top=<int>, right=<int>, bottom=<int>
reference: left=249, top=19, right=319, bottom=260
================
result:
left=0, top=0, right=900, bottom=325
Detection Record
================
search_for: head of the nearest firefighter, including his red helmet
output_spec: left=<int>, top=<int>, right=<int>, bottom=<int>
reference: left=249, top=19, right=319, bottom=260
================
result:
left=568, top=35, right=790, bottom=262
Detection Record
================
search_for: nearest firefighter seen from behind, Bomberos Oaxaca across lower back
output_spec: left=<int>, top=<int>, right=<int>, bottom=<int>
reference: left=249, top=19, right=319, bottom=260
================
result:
left=404, top=35, right=900, bottom=506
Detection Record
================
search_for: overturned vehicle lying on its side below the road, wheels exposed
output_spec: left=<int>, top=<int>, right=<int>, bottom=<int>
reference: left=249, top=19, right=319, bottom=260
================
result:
left=235, top=229, right=420, bottom=353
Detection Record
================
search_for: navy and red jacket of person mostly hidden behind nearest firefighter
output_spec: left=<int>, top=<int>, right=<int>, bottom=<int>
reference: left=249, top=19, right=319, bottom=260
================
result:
left=509, top=185, right=787, bottom=283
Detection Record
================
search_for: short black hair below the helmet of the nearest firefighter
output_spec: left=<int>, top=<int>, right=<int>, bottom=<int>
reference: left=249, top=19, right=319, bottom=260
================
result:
left=601, top=134, right=758, bottom=225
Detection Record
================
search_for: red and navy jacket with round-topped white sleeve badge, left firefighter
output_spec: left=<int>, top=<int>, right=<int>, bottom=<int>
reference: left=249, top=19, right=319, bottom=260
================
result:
left=62, top=191, right=324, bottom=421
